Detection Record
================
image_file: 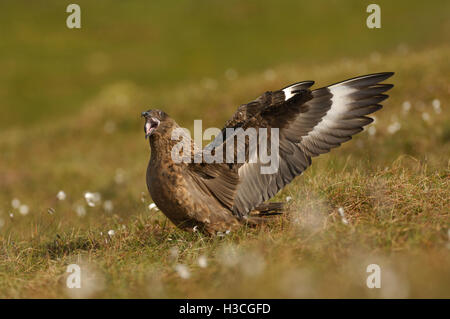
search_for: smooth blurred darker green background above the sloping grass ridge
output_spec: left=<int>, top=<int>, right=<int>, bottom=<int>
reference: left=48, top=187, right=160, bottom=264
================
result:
left=0, top=0, right=450, bottom=129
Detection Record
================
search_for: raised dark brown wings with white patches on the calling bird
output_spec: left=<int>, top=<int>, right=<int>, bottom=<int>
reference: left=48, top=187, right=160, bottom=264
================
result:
left=209, top=72, right=393, bottom=217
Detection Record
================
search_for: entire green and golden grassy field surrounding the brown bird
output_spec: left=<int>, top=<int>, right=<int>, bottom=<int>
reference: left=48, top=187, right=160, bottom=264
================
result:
left=0, top=0, right=450, bottom=298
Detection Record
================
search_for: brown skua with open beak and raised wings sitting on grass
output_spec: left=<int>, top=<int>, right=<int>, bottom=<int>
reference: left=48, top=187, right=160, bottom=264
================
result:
left=142, top=72, right=394, bottom=235
